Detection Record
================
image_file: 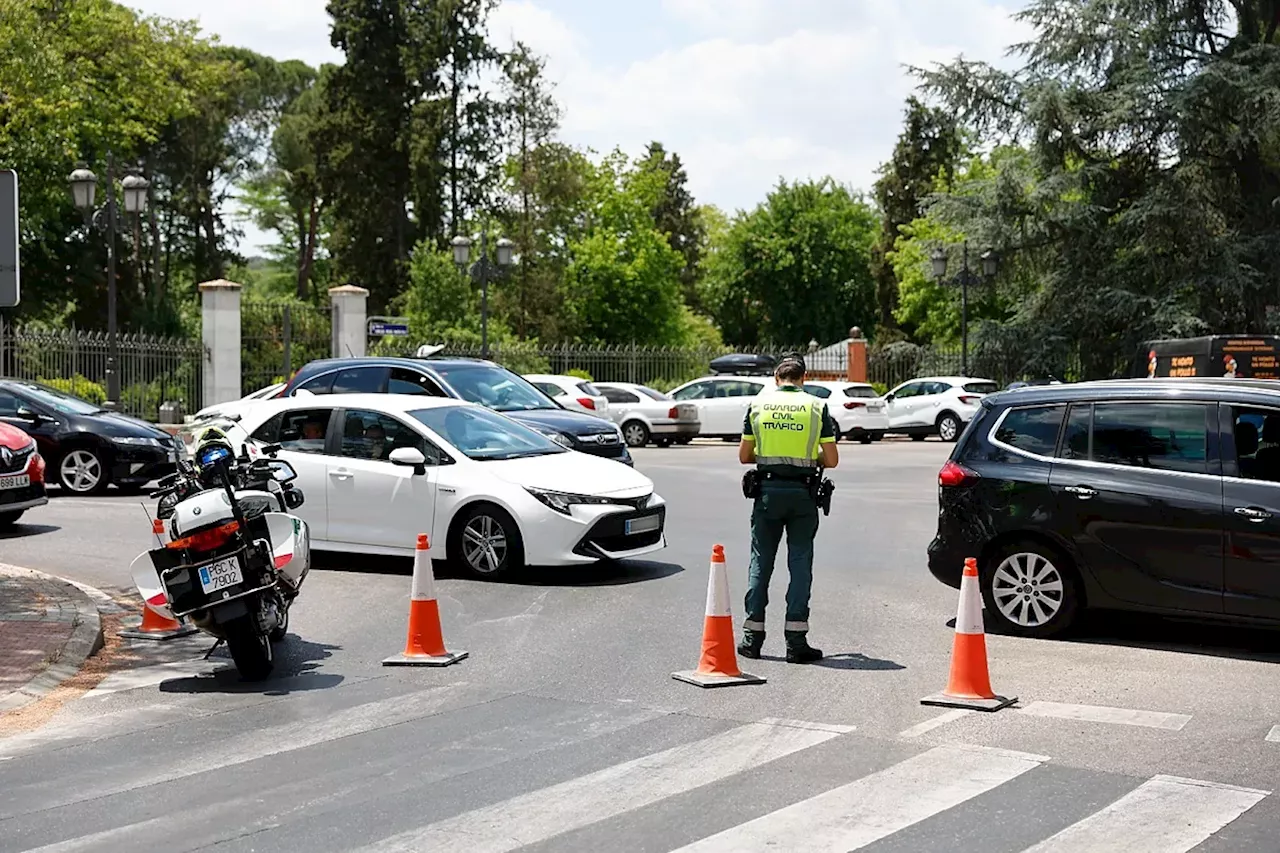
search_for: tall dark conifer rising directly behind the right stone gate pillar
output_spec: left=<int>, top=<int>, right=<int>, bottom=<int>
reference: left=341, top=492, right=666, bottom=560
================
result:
left=310, top=0, right=419, bottom=310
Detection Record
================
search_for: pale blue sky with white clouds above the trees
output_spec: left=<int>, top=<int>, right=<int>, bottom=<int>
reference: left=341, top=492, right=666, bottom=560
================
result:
left=125, top=0, right=1029, bottom=251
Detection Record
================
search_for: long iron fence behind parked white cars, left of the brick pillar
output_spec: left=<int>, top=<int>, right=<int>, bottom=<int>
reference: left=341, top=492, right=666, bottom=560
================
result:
left=370, top=341, right=849, bottom=391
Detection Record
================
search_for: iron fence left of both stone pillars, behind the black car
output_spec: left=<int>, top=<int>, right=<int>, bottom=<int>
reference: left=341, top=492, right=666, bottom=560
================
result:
left=0, top=324, right=202, bottom=420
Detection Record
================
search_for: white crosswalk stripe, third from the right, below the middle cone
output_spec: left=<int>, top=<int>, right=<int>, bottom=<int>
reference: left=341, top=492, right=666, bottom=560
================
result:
left=364, top=722, right=837, bottom=853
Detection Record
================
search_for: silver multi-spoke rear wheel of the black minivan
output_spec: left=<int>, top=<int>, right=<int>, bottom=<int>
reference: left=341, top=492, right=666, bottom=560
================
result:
left=982, top=542, right=1080, bottom=637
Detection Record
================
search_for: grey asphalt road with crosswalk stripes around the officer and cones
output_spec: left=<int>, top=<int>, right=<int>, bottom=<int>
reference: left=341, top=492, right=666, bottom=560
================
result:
left=0, top=441, right=1280, bottom=853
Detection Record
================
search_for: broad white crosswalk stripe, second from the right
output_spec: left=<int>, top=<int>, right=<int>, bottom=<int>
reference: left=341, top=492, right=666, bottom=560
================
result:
left=677, top=747, right=1046, bottom=853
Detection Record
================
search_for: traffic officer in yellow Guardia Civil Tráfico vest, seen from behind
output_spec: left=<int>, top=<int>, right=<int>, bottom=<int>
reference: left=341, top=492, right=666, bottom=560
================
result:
left=737, top=353, right=840, bottom=663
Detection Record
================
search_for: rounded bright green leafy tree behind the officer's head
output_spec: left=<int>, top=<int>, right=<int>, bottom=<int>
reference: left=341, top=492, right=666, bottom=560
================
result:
left=704, top=178, right=879, bottom=345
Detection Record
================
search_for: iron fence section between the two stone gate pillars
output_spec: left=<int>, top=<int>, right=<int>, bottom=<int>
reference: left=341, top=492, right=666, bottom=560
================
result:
left=241, top=301, right=333, bottom=393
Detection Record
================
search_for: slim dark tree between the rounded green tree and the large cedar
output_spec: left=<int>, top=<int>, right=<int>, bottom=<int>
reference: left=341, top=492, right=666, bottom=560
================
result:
left=872, top=97, right=963, bottom=339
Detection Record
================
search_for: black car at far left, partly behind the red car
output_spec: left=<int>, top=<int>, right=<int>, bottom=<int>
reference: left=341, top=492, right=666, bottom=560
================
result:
left=0, top=379, right=182, bottom=494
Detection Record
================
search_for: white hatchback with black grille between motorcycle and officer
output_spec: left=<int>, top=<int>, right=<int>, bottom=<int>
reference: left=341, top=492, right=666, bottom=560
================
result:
left=221, top=394, right=667, bottom=578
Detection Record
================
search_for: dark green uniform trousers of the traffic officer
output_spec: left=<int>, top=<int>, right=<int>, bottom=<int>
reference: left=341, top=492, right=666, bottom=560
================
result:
left=744, top=480, right=818, bottom=631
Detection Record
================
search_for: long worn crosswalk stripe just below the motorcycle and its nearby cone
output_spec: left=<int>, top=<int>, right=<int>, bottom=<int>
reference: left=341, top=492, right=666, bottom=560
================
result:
left=0, top=683, right=466, bottom=818
